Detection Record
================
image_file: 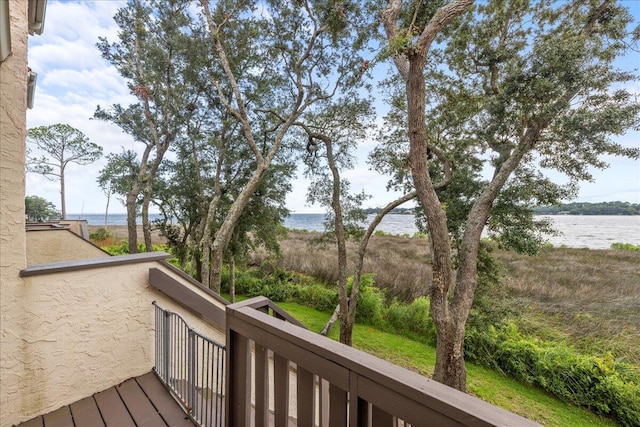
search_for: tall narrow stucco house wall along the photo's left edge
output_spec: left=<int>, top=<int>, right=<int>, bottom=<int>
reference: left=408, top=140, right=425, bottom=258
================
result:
left=0, top=0, right=27, bottom=426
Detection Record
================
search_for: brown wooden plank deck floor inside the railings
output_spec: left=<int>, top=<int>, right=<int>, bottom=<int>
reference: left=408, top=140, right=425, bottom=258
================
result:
left=19, top=372, right=195, bottom=427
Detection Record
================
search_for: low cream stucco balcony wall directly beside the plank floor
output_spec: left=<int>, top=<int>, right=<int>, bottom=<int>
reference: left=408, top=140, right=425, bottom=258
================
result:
left=1, top=262, right=224, bottom=426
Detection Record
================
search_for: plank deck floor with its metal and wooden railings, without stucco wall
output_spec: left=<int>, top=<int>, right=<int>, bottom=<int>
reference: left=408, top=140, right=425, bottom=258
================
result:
left=16, top=297, right=538, bottom=427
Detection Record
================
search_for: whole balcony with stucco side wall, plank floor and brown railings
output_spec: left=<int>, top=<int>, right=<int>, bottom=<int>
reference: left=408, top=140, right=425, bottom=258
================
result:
left=10, top=226, right=537, bottom=427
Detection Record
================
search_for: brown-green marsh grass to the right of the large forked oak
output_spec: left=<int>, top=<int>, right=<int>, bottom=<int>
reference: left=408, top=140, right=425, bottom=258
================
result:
left=497, top=248, right=640, bottom=366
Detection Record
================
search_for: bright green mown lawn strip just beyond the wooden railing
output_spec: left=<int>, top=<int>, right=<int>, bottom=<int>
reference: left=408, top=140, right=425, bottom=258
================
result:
left=278, top=302, right=617, bottom=427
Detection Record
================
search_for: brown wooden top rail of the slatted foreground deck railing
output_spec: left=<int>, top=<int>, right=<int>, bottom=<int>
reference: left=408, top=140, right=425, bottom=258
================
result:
left=227, top=298, right=539, bottom=427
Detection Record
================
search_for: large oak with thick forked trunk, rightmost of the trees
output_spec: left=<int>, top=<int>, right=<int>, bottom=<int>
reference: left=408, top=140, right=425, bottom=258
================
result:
left=382, top=0, right=640, bottom=390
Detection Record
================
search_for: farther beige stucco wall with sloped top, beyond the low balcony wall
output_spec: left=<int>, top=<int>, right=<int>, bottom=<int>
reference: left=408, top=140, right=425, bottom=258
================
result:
left=27, top=229, right=109, bottom=265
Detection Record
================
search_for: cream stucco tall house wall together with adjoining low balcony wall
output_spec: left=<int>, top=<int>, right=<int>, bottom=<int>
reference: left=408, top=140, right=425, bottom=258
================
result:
left=0, top=4, right=224, bottom=427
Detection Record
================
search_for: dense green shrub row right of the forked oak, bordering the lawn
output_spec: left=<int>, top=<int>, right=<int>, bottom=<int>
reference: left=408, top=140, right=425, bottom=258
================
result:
left=465, top=324, right=640, bottom=426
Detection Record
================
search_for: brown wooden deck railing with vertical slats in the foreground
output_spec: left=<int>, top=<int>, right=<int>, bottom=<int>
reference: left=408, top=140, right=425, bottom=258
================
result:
left=226, top=297, right=538, bottom=427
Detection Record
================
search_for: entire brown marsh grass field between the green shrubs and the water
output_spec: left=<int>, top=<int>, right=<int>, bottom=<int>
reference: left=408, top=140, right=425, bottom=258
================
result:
left=270, top=231, right=640, bottom=369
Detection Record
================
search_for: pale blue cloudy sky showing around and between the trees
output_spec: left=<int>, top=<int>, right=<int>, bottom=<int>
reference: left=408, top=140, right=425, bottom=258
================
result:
left=26, top=0, right=640, bottom=214
